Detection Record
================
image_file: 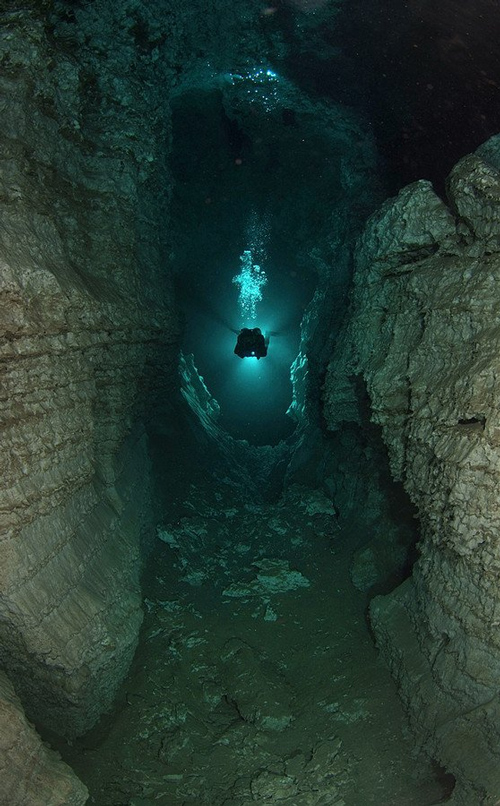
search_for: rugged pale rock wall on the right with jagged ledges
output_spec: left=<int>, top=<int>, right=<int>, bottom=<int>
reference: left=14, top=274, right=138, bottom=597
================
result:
left=324, top=139, right=500, bottom=806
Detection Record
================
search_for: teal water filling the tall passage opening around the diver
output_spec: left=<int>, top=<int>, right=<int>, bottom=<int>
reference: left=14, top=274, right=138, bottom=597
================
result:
left=172, top=91, right=335, bottom=444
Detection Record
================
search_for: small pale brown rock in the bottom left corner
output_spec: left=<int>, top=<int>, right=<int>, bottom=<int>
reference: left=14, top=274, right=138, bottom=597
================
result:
left=0, top=672, right=88, bottom=806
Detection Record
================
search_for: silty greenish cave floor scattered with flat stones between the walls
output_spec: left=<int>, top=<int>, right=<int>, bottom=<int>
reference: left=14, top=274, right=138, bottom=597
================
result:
left=64, top=460, right=443, bottom=806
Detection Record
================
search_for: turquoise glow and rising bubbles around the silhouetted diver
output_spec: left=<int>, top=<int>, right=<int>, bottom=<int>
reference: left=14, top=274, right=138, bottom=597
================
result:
left=183, top=205, right=302, bottom=444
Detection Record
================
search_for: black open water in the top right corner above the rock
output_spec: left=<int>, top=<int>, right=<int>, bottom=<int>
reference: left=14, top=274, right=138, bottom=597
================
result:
left=278, top=0, right=500, bottom=193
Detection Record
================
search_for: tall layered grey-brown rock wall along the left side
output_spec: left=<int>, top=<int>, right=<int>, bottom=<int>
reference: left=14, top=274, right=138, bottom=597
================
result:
left=0, top=3, right=182, bottom=740
